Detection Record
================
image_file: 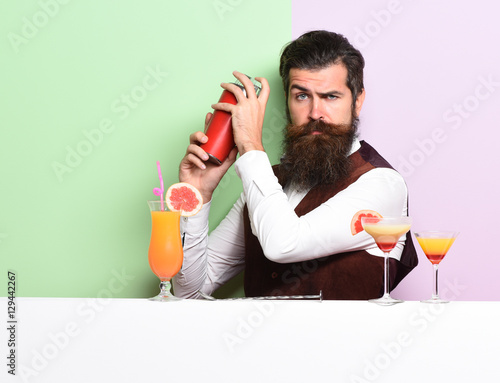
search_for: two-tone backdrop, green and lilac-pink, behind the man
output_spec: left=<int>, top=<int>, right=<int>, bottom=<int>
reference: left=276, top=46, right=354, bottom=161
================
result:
left=0, top=0, right=500, bottom=300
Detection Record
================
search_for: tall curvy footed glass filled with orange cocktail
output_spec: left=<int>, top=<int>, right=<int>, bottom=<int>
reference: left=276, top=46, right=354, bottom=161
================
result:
left=148, top=201, right=183, bottom=302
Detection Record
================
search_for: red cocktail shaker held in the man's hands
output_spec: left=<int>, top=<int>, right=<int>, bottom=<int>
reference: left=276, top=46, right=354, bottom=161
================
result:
left=200, top=76, right=260, bottom=165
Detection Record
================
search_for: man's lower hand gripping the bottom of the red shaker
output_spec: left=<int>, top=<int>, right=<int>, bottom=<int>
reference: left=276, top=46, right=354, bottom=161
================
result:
left=179, top=113, right=238, bottom=203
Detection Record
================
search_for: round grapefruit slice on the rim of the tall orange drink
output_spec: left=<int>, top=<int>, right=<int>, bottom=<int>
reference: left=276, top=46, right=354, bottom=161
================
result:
left=165, top=182, right=203, bottom=217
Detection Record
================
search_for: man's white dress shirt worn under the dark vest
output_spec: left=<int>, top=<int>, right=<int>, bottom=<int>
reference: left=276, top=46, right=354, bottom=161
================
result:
left=173, top=140, right=407, bottom=298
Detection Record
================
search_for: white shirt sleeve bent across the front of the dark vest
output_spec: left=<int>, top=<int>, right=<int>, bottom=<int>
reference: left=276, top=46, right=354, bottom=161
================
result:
left=236, top=151, right=407, bottom=263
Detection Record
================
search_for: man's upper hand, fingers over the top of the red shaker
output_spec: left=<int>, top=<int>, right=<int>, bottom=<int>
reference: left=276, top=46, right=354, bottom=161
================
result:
left=212, top=71, right=270, bottom=155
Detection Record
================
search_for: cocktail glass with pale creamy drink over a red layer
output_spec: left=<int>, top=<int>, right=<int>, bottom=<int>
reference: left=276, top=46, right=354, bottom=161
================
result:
left=361, top=216, right=411, bottom=306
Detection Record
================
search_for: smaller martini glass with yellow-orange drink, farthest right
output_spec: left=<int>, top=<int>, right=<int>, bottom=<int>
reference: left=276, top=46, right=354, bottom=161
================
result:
left=415, top=231, right=458, bottom=303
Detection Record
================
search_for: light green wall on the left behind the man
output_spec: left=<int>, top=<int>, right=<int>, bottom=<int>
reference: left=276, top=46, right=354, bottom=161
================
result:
left=0, top=0, right=291, bottom=297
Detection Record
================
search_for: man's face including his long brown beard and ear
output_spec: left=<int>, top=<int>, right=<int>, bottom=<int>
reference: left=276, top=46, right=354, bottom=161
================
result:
left=280, top=65, right=364, bottom=190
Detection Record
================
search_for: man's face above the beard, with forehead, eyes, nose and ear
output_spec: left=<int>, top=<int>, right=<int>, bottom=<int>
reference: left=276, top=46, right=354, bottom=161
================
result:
left=288, top=64, right=365, bottom=127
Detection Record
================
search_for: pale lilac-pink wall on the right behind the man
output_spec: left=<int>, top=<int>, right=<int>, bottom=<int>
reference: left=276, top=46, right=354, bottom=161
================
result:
left=292, top=0, right=500, bottom=300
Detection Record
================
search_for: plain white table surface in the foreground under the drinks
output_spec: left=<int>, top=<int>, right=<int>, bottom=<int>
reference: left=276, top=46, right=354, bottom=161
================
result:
left=0, top=298, right=500, bottom=383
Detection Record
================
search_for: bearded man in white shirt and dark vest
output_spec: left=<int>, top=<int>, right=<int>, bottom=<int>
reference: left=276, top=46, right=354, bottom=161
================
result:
left=174, top=31, right=418, bottom=299
